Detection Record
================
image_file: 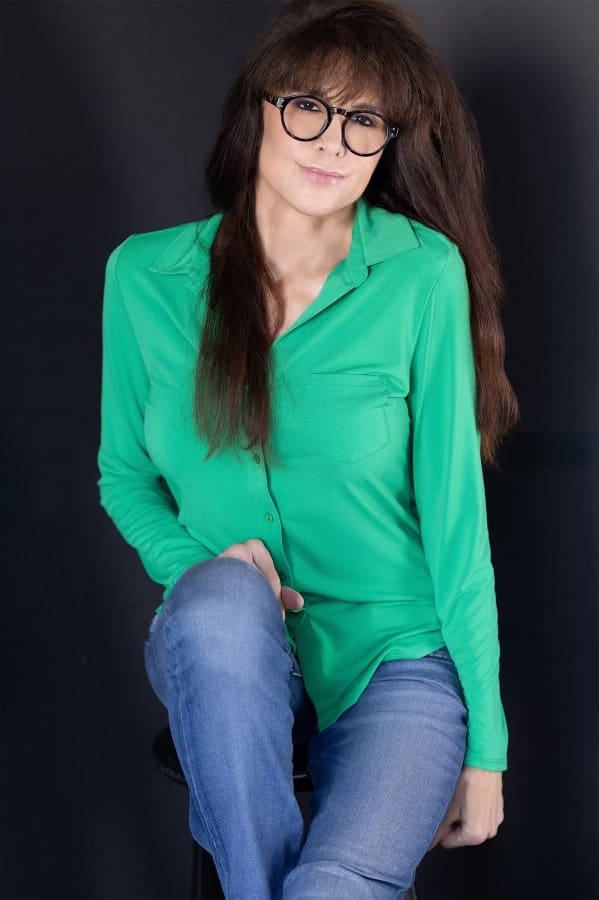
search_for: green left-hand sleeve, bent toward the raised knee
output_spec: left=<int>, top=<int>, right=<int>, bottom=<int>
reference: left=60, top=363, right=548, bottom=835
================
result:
left=97, top=235, right=214, bottom=600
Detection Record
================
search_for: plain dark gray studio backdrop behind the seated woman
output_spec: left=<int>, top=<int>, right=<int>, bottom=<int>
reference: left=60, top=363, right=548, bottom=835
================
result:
left=0, top=0, right=599, bottom=900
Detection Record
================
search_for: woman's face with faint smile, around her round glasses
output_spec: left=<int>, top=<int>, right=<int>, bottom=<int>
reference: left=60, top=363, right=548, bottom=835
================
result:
left=256, top=88, right=383, bottom=216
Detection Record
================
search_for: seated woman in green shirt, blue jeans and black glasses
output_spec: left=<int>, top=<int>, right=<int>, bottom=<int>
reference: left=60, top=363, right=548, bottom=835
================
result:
left=98, top=0, right=519, bottom=900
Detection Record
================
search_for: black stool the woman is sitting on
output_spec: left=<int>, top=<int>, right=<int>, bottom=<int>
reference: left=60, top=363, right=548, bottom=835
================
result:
left=152, top=725, right=418, bottom=900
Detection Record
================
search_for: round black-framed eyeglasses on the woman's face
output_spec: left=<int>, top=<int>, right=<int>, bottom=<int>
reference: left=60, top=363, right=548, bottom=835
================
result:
left=263, top=94, right=399, bottom=156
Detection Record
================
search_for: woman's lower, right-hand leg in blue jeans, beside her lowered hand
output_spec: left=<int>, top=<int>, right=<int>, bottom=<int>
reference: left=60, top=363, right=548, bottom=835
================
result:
left=283, top=648, right=468, bottom=900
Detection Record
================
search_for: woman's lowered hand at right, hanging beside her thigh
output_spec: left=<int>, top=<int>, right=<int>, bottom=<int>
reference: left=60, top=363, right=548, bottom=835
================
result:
left=427, top=766, right=503, bottom=852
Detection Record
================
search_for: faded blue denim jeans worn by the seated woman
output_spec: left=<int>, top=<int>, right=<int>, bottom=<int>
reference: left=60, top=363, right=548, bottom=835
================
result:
left=144, top=557, right=468, bottom=900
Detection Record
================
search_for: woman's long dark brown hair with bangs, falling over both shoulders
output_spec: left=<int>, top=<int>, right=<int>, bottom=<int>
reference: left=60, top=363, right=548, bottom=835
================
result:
left=194, top=0, right=520, bottom=468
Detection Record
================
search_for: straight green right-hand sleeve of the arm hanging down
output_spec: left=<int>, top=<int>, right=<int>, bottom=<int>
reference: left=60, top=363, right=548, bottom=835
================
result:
left=408, top=244, right=508, bottom=771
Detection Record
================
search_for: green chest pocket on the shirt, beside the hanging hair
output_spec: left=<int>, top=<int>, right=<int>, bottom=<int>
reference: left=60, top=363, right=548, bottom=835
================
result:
left=275, top=372, right=389, bottom=463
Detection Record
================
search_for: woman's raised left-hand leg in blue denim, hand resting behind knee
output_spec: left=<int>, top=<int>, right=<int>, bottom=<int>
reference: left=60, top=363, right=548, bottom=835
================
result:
left=145, top=557, right=318, bottom=900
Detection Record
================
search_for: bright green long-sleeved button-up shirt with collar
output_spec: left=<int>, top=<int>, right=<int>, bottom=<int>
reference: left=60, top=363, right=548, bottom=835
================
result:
left=98, top=198, right=508, bottom=771
